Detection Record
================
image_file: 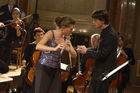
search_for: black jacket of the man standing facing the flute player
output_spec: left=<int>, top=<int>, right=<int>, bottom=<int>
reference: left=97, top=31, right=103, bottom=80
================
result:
left=86, top=25, right=118, bottom=80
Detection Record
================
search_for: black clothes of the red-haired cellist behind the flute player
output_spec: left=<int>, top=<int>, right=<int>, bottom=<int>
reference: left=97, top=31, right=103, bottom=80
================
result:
left=17, top=43, right=36, bottom=93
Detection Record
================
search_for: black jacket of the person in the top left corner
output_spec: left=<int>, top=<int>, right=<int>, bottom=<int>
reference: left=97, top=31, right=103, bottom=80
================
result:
left=0, top=4, right=17, bottom=22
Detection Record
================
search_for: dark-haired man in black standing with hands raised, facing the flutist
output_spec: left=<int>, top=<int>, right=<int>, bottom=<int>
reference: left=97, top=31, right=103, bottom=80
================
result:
left=77, top=10, right=118, bottom=93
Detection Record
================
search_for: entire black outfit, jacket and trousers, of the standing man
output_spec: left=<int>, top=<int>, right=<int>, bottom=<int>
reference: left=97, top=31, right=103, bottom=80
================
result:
left=86, top=25, right=118, bottom=93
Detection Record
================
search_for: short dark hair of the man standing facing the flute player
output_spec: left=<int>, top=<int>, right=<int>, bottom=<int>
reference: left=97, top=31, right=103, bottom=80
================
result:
left=92, top=10, right=109, bottom=24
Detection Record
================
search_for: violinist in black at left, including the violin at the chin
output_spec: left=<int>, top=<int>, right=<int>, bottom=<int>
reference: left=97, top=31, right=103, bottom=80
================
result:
left=0, top=8, right=25, bottom=65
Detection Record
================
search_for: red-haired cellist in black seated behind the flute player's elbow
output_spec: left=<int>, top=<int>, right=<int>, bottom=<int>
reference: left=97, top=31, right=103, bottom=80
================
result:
left=17, top=27, right=45, bottom=93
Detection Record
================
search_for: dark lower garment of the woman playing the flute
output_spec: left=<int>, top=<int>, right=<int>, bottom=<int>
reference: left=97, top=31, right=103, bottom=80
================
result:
left=34, top=63, right=61, bottom=93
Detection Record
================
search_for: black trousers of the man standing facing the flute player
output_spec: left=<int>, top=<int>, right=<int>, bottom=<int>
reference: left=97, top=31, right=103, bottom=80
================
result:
left=88, top=78, right=111, bottom=93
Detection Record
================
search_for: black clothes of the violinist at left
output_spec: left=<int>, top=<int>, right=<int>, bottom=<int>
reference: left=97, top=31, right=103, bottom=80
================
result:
left=0, top=20, right=25, bottom=65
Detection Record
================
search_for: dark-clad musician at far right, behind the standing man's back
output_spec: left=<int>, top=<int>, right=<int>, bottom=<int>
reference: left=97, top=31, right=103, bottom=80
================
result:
left=118, top=34, right=135, bottom=93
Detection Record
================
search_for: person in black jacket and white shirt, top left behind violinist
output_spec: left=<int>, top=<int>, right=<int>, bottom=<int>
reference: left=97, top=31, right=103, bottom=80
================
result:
left=0, top=0, right=17, bottom=22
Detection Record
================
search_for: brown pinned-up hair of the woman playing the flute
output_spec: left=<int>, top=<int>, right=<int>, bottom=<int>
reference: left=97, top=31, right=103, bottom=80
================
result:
left=55, top=16, right=75, bottom=28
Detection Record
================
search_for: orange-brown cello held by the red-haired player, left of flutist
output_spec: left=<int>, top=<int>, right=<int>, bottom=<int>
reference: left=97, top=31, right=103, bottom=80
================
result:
left=25, top=51, right=40, bottom=86
